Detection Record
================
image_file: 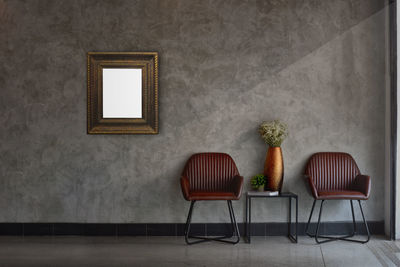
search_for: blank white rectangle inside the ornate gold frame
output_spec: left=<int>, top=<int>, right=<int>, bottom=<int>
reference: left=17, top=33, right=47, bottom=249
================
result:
left=103, top=68, right=142, bottom=118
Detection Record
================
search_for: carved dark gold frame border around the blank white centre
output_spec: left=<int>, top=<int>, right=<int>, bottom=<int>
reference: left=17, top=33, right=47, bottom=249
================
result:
left=87, top=52, right=158, bottom=134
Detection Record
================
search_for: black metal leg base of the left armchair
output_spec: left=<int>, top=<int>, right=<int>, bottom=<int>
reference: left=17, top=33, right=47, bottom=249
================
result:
left=185, top=200, right=240, bottom=245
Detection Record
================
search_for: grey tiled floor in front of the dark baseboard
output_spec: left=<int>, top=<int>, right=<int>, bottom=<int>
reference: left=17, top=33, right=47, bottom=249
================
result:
left=0, top=237, right=400, bottom=267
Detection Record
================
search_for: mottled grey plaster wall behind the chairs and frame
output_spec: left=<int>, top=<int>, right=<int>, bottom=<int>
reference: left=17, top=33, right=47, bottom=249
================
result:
left=0, top=0, right=386, bottom=222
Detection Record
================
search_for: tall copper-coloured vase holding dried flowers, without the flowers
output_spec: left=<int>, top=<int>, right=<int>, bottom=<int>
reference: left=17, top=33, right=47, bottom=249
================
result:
left=264, top=147, right=283, bottom=193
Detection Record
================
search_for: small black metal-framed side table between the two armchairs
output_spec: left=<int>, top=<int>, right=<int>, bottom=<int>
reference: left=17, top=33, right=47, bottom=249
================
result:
left=245, top=192, right=299, bottom=243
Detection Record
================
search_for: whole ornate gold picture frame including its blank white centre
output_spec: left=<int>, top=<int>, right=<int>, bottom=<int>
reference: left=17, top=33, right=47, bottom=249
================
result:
left=87, top=52, right=158, bottom=134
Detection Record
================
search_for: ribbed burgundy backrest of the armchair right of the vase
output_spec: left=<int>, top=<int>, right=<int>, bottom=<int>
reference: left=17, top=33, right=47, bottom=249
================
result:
left=306, top=152, right=360, bottom=190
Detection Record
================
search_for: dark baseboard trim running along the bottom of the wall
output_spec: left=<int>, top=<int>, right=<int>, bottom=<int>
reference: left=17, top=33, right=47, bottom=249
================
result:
left=0, top=221, right=384, bottom=236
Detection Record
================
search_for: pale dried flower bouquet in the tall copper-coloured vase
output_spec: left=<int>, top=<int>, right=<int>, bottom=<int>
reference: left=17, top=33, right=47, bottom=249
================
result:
left=258, top=120, right=288, bottom=147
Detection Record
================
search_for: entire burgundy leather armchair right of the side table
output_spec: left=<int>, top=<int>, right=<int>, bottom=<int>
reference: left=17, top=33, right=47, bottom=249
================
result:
left=305, top=152, right=371, bottom=243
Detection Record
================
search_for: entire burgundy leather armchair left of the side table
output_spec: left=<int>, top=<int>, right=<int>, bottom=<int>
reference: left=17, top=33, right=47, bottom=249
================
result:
left=181, top=153, right=243, bottom=244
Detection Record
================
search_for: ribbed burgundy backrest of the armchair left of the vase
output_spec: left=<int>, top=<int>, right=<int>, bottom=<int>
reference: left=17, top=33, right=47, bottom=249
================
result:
left=182, top=153, right=239, bottom=192
